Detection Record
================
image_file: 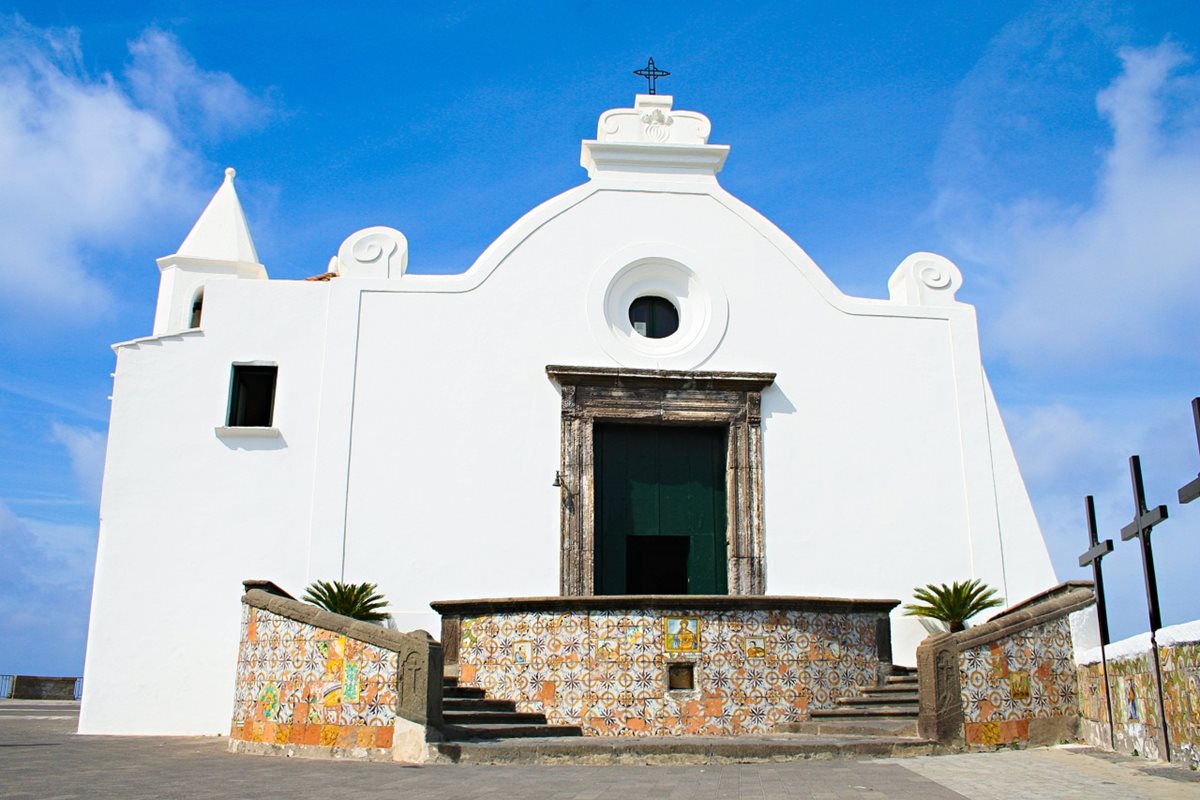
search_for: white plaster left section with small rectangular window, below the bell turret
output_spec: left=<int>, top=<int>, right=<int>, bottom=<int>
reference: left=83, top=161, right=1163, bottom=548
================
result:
left=79, top=281, right=326, bottom=734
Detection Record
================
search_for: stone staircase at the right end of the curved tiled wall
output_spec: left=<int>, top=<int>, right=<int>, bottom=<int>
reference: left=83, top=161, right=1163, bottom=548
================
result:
left=780, top=667, right=919, bottom=736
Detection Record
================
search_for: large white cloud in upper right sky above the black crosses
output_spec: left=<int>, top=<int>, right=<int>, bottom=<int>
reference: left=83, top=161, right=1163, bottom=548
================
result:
left=935, top=42, right=1200, bottom=368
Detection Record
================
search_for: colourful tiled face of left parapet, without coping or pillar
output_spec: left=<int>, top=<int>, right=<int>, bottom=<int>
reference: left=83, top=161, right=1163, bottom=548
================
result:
left=229, top=604, right=396, bottom=748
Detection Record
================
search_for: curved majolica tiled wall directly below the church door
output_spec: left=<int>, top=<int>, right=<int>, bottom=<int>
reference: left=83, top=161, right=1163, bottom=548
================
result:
left=458, top=609, right=886, bottom=736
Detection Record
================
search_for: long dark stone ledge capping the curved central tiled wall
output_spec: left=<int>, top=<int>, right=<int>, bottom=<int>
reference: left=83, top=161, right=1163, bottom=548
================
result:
left=430, top=595, right=900, bottom=616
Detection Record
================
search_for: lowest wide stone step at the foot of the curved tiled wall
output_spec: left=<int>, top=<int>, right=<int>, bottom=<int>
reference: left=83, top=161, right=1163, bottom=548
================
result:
left=434, top=734, right=953, bottom=765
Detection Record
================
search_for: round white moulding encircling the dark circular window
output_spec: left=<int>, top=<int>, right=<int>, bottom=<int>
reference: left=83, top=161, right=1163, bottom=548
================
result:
left=587, top=243, right=730, bottom=369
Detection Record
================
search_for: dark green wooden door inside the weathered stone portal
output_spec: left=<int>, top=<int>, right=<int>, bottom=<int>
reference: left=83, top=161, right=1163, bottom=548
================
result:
left=594, top=425, right=728, bottom=595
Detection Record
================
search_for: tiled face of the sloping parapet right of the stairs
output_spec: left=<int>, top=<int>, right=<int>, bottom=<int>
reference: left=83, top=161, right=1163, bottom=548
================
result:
left=959, top=616, right=1078, bottom=745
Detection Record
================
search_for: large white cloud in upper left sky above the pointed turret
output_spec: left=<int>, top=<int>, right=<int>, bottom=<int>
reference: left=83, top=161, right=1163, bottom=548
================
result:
left=0, top=17, right=271, bottom=321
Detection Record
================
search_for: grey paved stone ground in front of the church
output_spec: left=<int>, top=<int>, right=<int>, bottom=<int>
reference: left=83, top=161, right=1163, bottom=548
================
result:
left=0, top=700, right=1200, bottom=800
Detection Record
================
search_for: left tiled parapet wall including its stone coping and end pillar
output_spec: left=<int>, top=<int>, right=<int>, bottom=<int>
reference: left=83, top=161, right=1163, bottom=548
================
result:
left=229, top=589, right=442, bottom=760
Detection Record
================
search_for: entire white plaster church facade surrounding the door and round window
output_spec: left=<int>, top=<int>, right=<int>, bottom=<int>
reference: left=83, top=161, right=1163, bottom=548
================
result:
left=87, top=163, right=1054, bottom=734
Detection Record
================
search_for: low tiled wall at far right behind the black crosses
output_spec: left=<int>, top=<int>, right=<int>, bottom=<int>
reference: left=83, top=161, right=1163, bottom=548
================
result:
left=1079, top=643, right=1200, bottom=766
